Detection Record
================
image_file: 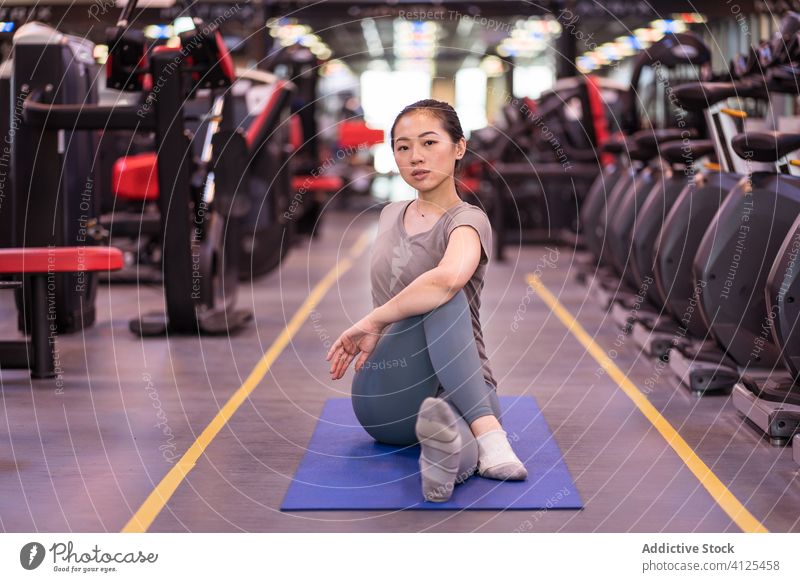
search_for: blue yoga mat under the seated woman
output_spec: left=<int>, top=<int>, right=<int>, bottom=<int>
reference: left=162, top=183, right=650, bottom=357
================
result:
left=281, top=396, right=583, bottom=511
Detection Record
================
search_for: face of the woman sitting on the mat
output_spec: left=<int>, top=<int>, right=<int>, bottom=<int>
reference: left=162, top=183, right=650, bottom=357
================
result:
left=394, top=111, right=466, bottom=192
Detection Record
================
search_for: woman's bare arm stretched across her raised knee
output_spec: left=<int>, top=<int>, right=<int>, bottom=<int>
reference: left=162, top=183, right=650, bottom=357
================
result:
left=325, top=225, right=481, bottom=380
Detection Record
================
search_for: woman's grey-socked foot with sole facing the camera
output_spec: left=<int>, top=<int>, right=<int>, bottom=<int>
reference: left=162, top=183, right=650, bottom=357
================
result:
left=416, top=397, right=462, bottom=502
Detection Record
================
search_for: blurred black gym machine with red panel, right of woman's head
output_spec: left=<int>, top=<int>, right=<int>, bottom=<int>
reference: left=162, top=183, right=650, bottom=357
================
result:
left=465, top=76, right=623, bottom=260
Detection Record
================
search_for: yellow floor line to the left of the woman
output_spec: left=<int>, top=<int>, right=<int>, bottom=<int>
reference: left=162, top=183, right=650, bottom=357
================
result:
left=122, top=228, right=373, bottom=533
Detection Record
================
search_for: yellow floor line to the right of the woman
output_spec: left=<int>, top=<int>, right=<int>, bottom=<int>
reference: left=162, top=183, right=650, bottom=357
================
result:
left=527, top=274, right=768, bottom=533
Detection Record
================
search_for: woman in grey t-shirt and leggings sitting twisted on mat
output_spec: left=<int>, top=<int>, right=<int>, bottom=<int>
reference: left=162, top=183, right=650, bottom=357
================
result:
left=326, top=99, right=527, bottom=502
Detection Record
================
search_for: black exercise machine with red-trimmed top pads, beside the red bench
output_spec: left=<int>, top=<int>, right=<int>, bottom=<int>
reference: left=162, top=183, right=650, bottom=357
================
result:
left=15, top=9, right=251, bottom=336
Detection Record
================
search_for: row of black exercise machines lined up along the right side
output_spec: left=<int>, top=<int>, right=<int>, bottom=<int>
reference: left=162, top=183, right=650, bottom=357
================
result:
left=579, top=13, right=800, bottom=470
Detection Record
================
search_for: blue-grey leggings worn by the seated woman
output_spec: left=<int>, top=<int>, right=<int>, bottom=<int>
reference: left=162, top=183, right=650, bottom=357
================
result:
left=352, top=289, right=500, bottom=466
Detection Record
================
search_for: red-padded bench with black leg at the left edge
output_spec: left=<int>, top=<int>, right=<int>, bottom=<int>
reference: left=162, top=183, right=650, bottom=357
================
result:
left=0, top=247, right=123, bottom=378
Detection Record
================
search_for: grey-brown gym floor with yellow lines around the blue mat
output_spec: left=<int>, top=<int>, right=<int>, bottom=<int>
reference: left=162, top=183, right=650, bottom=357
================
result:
left=0, top=205, right=800, bottom=532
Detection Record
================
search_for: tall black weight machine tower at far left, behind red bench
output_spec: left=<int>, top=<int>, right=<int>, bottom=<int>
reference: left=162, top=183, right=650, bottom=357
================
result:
left=10, top=23, right=99, bottom=333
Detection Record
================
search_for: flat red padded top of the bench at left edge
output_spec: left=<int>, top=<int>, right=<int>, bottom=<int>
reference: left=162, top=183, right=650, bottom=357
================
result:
left=0, top=247, right=124, bottom=275
